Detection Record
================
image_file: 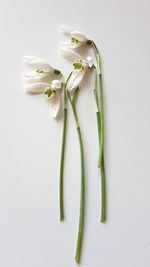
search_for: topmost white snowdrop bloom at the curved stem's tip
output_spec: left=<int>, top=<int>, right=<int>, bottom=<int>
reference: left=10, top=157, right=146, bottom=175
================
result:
left=60, top=25, right=89, bottom=49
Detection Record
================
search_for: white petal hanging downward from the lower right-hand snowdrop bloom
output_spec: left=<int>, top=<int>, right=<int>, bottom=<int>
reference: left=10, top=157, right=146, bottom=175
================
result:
left=67, top=69, right=85, bottom=91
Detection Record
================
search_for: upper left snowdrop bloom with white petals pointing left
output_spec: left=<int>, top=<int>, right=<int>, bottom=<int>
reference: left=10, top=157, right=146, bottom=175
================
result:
left=24, top=56, right=61, bottom=93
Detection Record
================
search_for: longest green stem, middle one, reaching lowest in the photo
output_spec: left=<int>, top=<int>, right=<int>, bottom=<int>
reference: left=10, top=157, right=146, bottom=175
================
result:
left=68, top=92, right=85, bottom=263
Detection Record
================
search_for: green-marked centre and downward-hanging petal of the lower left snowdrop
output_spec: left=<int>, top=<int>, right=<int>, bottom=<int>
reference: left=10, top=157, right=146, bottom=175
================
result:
left=44, top=80, right=62, bottom=118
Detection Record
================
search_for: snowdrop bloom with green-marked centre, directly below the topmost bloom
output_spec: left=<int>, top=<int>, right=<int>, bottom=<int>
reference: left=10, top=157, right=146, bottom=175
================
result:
left=60, top=47, right=94, bottom=92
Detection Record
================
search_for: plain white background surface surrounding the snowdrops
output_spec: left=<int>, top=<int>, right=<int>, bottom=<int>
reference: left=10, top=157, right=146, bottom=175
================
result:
left=0, top=0, right=150, bottom=267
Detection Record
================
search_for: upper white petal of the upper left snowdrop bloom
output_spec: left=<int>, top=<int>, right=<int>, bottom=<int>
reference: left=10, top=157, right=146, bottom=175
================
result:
left=28, top=59, right=54, bottom=72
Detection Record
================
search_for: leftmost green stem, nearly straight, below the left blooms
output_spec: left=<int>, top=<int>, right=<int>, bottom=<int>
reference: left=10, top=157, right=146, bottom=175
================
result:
left=59, top=73, right=72, bottom=221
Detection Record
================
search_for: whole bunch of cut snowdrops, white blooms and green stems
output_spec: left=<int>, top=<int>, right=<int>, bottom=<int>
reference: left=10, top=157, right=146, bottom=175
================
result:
left=24, top=26, right=106, bottom=263
